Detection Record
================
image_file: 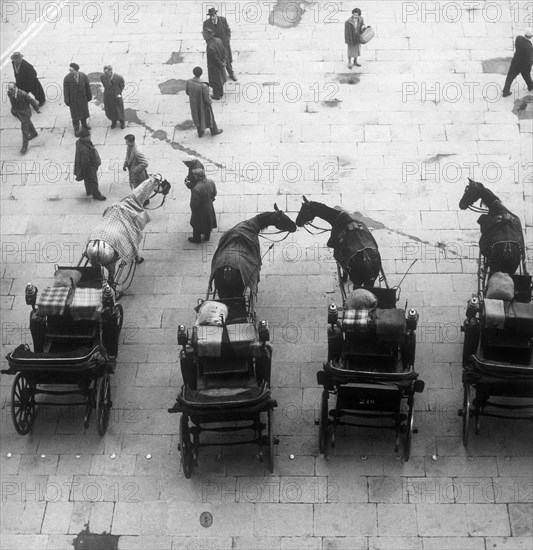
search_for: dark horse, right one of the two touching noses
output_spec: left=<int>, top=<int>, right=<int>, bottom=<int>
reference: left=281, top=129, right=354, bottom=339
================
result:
left=296, top=196, right=381, bottom=287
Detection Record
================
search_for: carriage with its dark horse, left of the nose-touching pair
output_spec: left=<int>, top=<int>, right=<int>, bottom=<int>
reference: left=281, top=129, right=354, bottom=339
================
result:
left=169, top=207, right=296, bottom=478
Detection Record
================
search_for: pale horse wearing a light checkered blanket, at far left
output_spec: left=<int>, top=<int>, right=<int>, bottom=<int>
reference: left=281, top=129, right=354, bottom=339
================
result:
left=85, top=174, right=170, bottom=285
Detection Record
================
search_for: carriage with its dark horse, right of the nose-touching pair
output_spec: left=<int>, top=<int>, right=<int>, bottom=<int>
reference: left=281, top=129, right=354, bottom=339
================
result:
left=296, top=197, right=424, bottom=461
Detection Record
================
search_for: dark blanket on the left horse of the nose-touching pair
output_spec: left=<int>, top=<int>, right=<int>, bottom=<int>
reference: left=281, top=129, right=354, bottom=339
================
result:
left=209, top=218, right=261, bottom=293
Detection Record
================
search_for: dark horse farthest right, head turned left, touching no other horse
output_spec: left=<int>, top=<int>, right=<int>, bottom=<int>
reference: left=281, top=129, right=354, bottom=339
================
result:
left=459, top=178, right=525, bottom=275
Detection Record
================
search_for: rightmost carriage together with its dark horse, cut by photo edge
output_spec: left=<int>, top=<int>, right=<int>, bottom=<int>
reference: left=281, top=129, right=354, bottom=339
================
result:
left=459, top=180, right=533, bottom=446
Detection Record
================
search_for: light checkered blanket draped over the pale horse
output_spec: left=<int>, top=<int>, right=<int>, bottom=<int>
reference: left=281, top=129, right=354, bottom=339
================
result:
left=89, top=178, right=158, bottom=261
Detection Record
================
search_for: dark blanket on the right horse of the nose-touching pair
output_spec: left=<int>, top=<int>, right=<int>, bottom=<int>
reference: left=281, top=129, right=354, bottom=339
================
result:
left=327, top=210, right=378, bottom=271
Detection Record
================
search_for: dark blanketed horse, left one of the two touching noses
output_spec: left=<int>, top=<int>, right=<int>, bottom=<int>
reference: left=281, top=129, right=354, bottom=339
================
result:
left=209, top=204, right=296, bottom=299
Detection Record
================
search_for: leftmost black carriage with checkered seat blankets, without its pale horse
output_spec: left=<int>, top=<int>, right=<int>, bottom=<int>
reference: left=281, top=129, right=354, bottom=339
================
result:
left=2, top=266, right=123, bottom=435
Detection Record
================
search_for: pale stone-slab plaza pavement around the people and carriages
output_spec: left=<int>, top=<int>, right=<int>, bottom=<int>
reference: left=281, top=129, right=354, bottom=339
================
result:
left=0, top=0, right=533, bottom=550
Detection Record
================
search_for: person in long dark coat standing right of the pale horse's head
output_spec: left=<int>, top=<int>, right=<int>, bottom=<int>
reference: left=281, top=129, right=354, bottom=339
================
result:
left=189, top=168, right=217, bottom=243
